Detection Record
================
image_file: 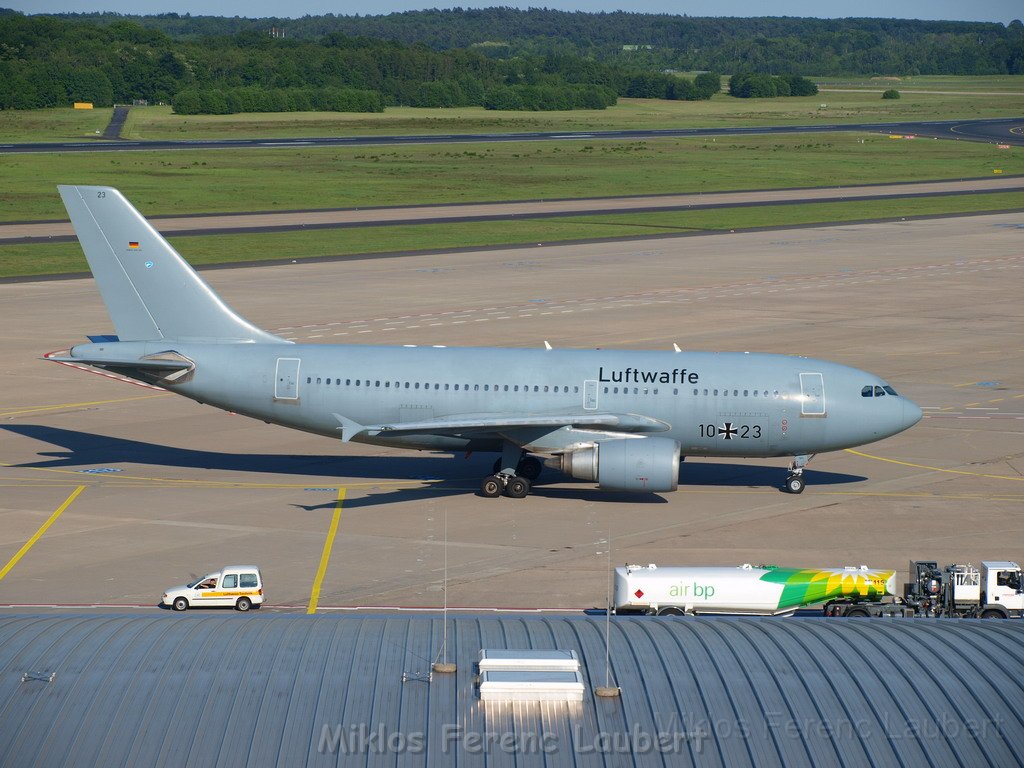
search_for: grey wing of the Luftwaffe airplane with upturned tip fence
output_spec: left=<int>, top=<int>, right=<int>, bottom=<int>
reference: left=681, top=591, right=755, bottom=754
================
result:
left=334, top=412, right=670, bottom=440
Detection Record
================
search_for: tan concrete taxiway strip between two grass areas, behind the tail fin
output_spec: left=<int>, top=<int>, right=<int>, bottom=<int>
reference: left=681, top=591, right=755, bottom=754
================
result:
left=0, top=176, right=1024, bottom=245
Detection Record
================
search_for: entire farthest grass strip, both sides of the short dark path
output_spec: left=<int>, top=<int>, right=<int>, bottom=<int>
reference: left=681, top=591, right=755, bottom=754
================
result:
left=0, top=75, right=1024, bottom=142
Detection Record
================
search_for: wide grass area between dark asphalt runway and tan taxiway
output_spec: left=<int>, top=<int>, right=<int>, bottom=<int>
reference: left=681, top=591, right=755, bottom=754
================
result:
left=0, top=133, right=1024, bottom=221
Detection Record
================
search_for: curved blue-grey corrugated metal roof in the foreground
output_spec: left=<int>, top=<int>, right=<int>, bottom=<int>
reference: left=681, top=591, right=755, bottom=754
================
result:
left=0, top=613, right=1024, bottom=767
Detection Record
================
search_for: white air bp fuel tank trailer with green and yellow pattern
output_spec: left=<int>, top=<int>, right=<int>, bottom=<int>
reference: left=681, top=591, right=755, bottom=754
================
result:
left=614, top=563, right=896, bottom=616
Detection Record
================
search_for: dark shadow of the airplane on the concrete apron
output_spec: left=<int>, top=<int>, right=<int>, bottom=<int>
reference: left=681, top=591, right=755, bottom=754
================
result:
left=0, top=424, right=866, bottom=510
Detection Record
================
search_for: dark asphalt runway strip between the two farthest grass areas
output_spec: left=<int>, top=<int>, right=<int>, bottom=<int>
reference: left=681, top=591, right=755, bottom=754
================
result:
left=0, top=118, right=1024, bottom=155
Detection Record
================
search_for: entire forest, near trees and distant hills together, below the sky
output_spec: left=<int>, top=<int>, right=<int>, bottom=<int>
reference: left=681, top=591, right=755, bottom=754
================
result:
left=0, top=8, right=1024, bottom=114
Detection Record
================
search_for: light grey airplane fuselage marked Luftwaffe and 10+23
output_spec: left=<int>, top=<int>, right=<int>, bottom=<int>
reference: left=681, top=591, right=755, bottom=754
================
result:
left=75, top=342, right=921, bottom=457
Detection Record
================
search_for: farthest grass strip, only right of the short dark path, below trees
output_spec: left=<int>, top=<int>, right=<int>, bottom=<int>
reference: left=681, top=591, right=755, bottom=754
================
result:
left=124, top=88, right=1024, bottom=139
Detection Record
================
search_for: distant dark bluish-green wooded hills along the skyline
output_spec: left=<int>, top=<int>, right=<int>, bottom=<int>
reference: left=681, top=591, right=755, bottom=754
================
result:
left=32, top=7, right=1024, bottom=76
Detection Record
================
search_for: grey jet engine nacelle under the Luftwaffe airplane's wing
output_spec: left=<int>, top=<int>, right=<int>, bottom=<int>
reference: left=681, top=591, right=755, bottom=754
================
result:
left=548, top=437, right=679, bottom=493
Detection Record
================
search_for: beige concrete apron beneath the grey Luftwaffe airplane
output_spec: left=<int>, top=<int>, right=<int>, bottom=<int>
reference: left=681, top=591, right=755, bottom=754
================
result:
left=0, top=213, right=1024, bottom=612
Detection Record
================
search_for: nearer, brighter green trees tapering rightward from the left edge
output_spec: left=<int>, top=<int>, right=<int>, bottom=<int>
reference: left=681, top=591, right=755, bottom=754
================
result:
left=0, top=12, right=720, bottom=114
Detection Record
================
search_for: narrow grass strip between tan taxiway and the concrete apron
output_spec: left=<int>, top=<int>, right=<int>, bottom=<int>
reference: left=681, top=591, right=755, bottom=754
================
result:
left=6, top=193, right=1024, bottom=278
